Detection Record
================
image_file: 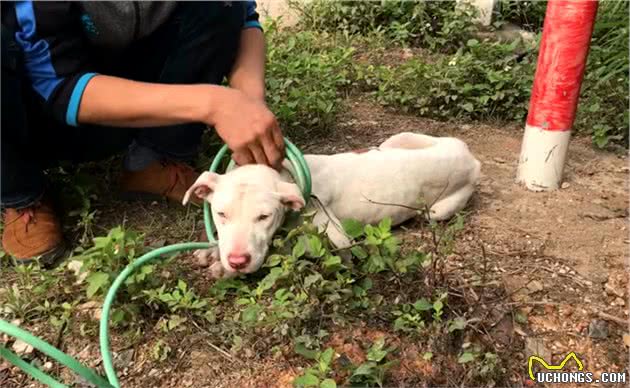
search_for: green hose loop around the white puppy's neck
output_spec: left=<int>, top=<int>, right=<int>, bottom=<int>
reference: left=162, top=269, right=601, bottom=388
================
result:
left=203, top=137, right=311, bottom=243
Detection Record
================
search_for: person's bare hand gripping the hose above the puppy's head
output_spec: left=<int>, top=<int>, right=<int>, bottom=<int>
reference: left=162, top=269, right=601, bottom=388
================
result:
left=207, top=87, right=284, bottom=169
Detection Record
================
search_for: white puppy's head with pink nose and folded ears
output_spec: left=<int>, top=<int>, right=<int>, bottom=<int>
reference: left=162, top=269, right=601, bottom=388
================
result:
left=183, top=165, right=305, bottom=273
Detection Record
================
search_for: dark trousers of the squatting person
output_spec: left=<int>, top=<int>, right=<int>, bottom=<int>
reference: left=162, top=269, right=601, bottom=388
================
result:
left=0, top=2, right=245, bottom=208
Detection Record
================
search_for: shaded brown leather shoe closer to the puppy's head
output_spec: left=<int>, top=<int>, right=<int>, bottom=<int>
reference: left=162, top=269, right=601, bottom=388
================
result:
left=120, top=161, right=202, bottom=204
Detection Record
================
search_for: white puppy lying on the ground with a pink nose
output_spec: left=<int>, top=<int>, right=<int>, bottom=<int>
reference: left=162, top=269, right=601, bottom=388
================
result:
left=183, top=133, right=481, bottom=277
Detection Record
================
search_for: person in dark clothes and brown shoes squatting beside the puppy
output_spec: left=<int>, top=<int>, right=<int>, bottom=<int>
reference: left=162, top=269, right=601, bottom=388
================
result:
left=1, top=1, right=284, bottom=263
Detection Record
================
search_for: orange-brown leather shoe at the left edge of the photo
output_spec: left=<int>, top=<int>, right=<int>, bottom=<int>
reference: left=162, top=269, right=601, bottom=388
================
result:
left=2, top=201, right=65, bottom=266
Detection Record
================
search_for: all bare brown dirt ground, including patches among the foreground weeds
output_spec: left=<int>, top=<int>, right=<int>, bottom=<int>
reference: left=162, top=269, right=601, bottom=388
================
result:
left=0, top=100, right=630, bottom=387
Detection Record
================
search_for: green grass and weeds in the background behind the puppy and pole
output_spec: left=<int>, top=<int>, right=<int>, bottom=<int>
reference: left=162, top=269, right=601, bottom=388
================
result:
left=278, top=0, right=629, bottom=148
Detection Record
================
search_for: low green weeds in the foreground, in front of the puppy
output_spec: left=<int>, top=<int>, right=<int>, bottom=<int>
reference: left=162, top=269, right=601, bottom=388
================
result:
left=0, top=209, right=507, bottom=387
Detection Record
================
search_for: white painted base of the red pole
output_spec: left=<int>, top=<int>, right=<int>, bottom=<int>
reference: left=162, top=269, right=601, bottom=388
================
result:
left=516, top=125, right=571, bottom=191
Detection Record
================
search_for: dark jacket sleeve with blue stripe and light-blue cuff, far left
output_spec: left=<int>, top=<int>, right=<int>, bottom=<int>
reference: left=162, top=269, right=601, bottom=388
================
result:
left=2, top=1, right=96, bottom=126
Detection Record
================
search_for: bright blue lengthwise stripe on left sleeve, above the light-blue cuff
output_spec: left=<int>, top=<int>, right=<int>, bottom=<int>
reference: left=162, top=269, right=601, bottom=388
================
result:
left=15, top=1, right=63, bottom=100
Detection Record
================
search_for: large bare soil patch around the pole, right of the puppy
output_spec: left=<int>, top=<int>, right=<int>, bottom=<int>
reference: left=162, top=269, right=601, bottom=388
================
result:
left=305, top=101, right=630, bottom=383
